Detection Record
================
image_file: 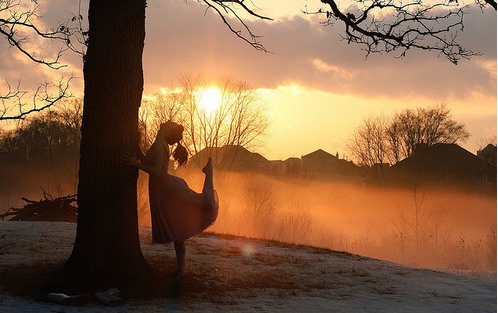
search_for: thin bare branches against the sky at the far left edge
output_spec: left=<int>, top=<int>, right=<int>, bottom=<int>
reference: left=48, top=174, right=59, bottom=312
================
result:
left=0, top=0, right=83, bottom=121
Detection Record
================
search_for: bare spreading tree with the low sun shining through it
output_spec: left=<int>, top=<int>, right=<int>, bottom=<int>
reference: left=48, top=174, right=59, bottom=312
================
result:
left=140, top=76, right=269, bottom=167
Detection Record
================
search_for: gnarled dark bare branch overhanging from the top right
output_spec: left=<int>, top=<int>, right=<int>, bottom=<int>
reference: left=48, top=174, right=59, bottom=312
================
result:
left=305, top=0, right=492, bottom=64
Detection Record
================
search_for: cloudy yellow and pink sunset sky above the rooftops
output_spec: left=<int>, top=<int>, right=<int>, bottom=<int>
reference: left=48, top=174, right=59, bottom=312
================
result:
left=0, top=0, right=497, bottom=159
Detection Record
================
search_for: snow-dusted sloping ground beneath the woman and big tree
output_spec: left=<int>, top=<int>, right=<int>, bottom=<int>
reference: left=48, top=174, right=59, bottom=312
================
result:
left=0, top=222, right=497, bottom=313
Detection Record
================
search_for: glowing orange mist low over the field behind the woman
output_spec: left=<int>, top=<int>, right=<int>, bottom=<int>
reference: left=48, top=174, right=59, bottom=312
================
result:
left=139, top=167, right=497, bottom=271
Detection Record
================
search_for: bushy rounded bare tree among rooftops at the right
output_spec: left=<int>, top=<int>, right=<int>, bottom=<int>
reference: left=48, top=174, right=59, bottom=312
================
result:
left=348, top=105, right=470, bottom=167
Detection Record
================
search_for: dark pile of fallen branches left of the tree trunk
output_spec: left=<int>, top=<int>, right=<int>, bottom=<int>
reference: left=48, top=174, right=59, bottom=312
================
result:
left=0, top=191, right=78, bottom=223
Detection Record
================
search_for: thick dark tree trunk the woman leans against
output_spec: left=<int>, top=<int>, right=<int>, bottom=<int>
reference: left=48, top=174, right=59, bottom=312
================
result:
left=65, top=0, right=147, bottom=287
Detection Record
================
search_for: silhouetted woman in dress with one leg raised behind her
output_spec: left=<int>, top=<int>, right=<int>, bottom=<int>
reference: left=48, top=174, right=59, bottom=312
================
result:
left=127, top=121, right=218, bottom=278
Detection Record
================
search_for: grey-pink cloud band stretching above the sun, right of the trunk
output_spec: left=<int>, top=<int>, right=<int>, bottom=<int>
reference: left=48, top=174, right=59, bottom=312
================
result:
left=144, top=1, right=496, bottom=103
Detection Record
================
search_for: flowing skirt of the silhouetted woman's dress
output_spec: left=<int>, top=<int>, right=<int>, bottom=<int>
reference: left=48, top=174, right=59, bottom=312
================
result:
left=149, top=174, right=219, bottom=243
